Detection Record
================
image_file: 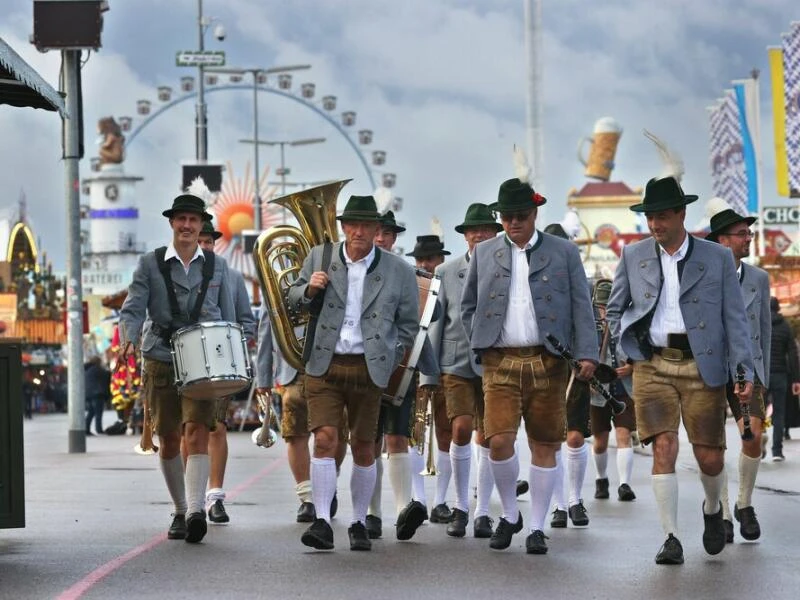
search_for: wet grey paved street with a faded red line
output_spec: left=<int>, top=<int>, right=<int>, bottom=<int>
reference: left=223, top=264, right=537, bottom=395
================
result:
left=0, top=413, right=800, bottom=600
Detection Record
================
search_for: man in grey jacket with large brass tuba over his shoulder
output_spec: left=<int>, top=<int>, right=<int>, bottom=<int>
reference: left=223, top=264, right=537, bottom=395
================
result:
left=288, top=196, right=419, bottom=550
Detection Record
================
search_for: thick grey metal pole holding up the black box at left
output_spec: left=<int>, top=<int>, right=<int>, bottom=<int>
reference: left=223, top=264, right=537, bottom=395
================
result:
left=61, top=50, right=86, bottom=454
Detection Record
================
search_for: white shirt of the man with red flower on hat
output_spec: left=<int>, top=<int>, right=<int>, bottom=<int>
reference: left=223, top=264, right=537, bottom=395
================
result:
left=497, top=229, right=542, bottom=348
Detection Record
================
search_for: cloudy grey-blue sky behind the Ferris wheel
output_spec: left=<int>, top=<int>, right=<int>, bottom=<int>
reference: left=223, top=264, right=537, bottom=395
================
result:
left=0, top=0, right=800, bottom=269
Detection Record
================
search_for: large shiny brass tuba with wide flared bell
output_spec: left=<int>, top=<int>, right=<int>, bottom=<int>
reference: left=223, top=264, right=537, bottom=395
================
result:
left=253, top=179, right=351, bottom=370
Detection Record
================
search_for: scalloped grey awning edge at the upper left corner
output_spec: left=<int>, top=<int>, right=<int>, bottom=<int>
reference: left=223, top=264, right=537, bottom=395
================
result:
left=0, top=39, right=65, bottom=116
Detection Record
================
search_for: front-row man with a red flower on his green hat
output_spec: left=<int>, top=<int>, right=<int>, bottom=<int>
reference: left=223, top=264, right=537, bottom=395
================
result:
left=461, top=178, right=597, bottom=554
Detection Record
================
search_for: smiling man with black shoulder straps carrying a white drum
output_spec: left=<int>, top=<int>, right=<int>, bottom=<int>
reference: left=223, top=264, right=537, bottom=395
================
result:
left=119, top=188, right=236, bottom=543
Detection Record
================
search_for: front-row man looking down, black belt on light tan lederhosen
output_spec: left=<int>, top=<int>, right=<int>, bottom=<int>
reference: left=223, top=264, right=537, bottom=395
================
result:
left=607, top=176, right=753, bottom=564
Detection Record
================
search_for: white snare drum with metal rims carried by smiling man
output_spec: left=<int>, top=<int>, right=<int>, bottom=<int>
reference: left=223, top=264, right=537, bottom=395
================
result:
left=172, top=321, right=252, bottom=400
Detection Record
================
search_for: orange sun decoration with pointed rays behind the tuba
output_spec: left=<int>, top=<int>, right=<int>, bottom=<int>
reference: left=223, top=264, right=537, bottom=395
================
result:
left=209, top=163, right=281, bottom=279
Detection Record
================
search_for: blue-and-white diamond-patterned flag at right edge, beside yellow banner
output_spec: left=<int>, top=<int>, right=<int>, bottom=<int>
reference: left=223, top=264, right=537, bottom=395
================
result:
left=782, top=22, right=800, bottom=198
